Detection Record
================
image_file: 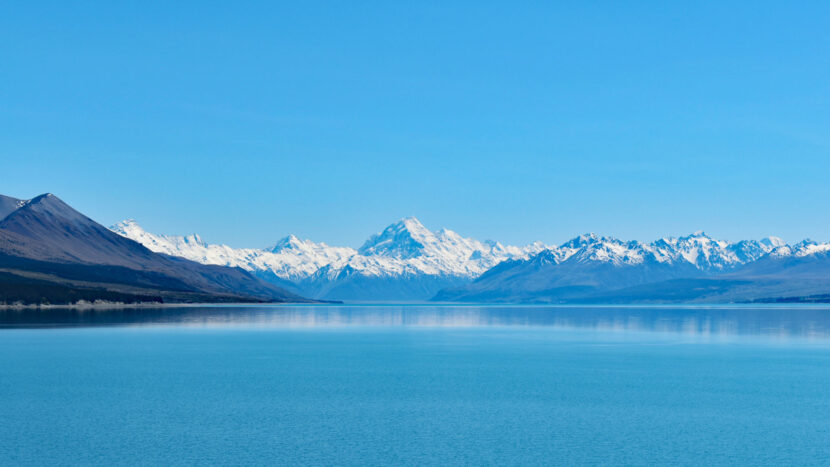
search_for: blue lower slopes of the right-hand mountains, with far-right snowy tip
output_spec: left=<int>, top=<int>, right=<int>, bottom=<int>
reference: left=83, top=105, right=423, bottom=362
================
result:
left=434, top=241, right=830, bottom=303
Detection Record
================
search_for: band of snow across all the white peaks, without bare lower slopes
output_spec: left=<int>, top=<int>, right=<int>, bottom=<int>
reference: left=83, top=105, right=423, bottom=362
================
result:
left=111, top=217, right=830, bottom=290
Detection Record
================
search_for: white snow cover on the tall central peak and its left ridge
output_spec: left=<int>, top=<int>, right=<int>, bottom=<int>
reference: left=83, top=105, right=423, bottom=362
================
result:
left=111, top=217, right=546, bottom=282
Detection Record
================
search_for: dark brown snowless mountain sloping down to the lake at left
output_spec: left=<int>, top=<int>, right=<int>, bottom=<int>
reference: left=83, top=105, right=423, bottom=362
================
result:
left=0, top=194, right=310, bottom=303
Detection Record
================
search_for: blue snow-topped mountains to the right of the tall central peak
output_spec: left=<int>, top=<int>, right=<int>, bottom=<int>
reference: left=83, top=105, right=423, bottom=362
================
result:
left=434, top=232, right=830, bottom=303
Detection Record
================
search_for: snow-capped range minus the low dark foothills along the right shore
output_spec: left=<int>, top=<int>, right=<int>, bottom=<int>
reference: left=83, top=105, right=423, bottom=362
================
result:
left=112, top=217, right=830, bottom=301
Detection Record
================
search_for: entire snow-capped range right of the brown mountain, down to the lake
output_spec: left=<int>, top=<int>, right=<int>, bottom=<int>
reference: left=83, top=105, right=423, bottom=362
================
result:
left=112, top=217, right=830, bottom=303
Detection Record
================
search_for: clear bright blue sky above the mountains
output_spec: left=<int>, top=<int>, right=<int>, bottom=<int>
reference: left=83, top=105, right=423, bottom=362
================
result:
left=0, top=1, right=830, bottom=246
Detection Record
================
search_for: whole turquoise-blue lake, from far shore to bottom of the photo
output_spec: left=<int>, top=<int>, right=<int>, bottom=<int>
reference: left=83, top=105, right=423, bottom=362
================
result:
left=0, top=305, right=830, bottom=465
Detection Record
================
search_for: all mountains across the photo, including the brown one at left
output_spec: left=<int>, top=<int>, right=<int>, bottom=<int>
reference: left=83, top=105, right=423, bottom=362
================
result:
left=0, top=194, right=830, bottom=304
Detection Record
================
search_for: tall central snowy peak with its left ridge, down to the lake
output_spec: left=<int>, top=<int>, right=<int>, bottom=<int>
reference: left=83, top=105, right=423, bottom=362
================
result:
left=112, top=217, right=545, bottom=301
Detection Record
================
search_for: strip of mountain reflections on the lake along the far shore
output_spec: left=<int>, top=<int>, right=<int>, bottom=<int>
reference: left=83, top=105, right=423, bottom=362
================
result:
left=0, top=305, right=830, bottom=339
